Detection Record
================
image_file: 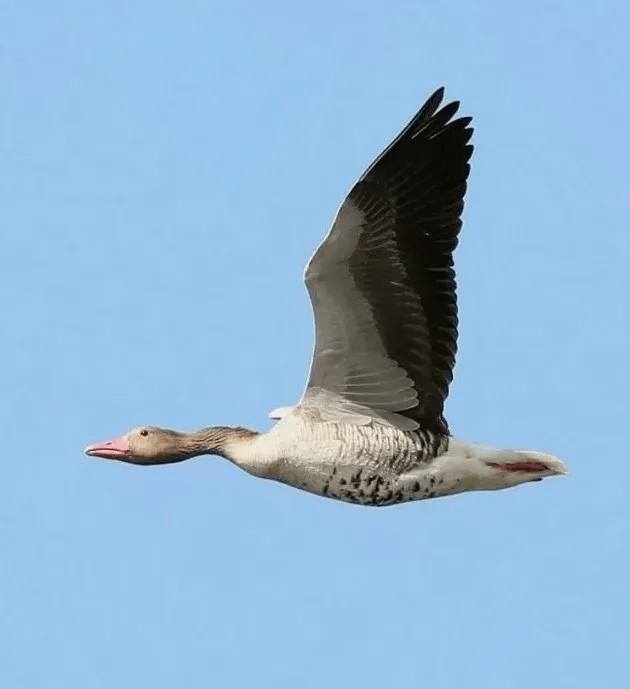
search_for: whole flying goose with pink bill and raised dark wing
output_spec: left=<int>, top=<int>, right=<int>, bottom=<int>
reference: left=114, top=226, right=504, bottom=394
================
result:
left=85, top=88, right=567, bottom=506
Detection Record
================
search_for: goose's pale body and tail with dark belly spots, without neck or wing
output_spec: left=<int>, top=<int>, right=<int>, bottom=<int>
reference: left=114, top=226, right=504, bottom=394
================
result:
left=212, top=414, right=566, bottom=506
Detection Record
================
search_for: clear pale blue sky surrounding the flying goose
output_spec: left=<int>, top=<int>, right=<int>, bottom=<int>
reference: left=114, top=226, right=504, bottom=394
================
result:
left=0, top=0, right=630, bottom=689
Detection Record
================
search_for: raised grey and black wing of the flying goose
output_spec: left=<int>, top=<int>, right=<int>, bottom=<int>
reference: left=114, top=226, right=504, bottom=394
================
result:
left=301, top=89, right=473, bottom=432
